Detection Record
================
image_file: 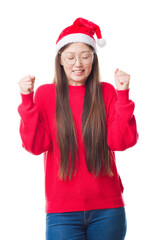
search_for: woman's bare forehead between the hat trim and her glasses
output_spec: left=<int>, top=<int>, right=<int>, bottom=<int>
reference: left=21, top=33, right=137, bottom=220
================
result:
left=63, top=42, right=91, bottom=53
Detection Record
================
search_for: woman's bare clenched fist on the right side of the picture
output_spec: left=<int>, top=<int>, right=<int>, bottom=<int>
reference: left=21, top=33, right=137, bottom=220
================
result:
left=114, top=68, right=130, bottom=90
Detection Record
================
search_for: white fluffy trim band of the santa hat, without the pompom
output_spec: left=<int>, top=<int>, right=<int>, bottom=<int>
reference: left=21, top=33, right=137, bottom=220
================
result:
left=56, top=33, right=97, bottom=52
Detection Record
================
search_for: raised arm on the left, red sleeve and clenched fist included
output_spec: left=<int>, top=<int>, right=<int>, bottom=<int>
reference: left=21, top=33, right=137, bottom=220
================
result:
left=18, top=75, right=50, bottom=155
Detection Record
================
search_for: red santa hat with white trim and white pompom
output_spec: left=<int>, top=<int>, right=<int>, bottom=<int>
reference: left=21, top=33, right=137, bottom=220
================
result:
left=56, top=18, right=106, bottom=52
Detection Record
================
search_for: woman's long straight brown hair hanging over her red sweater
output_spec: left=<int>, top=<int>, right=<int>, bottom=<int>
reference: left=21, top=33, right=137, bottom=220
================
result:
left=54, top=44, right=113, bottom=180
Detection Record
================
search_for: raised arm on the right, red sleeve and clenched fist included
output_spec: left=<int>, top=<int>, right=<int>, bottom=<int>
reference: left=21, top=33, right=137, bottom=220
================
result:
left=106, top=69, right=138, bottom=151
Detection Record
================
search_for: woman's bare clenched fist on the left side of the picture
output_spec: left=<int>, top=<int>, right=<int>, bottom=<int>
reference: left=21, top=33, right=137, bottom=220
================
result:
left=18, top=75, right=35, bottom=94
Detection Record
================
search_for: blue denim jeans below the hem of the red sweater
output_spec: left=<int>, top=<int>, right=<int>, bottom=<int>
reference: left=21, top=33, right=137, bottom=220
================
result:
left=46, top=207, right=127, bottom=240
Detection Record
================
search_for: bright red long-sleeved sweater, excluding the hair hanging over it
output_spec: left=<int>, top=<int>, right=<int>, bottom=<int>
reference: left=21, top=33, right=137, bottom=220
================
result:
left=18, top=82, right=138, bottom=213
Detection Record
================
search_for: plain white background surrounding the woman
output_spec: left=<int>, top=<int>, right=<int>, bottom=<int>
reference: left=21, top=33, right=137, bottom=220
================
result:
left=0, top=0, right=156, bottom=240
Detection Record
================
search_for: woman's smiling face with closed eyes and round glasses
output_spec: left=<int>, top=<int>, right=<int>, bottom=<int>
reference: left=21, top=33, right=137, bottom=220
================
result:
left=60, top=42, right=93, bottom=86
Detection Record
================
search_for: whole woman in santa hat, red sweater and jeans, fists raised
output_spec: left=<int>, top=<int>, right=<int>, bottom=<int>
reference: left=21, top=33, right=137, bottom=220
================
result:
left=18, top=18, right=138, bottom=240
